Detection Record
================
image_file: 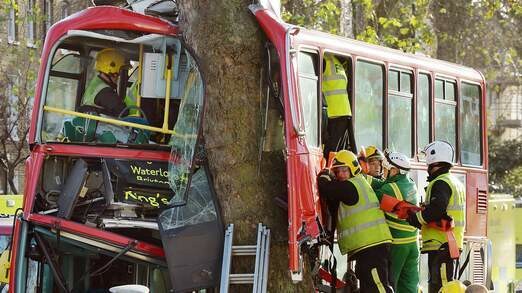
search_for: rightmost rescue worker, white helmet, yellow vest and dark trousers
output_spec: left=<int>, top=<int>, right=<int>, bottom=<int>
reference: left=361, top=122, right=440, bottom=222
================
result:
left=407, top=141, right=466, bottom=293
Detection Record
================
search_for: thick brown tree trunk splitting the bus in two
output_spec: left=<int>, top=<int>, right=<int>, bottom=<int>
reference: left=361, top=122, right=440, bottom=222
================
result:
left=178, top=0, right=312, bottom=292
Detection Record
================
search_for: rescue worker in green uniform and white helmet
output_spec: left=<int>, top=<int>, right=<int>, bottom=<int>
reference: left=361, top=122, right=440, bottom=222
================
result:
left=375, top=152, right=419, bottom=293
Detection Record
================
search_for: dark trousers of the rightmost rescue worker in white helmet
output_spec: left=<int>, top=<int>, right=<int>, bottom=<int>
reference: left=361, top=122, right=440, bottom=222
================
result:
left=428, top=249, right=455, bottom=293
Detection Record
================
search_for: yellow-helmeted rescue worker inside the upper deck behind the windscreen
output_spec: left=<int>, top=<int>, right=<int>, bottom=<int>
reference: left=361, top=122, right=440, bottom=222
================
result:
left=82, top=48, right=136, bottom=117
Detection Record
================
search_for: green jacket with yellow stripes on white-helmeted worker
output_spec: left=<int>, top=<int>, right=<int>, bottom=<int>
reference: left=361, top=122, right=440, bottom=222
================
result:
left=375, top=174, right=419, bottom=244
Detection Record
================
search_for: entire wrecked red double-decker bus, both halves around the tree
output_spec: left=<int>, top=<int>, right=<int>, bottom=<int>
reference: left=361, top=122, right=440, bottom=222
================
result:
left=9, top=5, right=488, bottom=292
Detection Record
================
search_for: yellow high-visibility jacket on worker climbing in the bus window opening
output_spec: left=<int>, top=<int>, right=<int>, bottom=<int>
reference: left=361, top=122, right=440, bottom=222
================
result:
left=323, top=55, right=352, bottom=118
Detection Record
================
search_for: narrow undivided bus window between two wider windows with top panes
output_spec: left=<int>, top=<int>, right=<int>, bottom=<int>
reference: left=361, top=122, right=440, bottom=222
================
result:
left=417, top=73, right=430, bottom=148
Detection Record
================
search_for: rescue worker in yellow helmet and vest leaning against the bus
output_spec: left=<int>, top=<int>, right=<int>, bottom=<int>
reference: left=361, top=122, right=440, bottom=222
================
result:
left=318, top=150, right=393, bottom=293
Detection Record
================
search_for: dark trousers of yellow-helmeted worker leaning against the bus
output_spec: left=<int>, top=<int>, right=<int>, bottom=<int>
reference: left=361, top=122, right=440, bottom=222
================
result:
left=353, top=243, right=393, bottom=293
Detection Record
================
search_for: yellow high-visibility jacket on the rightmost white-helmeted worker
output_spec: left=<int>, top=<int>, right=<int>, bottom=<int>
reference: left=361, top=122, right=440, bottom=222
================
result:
left=417, top=173, right=466, bottom=252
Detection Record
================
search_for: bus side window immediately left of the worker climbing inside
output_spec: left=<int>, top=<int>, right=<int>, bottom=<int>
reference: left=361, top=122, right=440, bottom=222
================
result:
left=297, top=52, right=319, bottom=147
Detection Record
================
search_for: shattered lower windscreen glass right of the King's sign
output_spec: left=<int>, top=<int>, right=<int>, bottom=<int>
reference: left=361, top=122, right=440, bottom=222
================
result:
left=158, top=168, right=217, bottom=231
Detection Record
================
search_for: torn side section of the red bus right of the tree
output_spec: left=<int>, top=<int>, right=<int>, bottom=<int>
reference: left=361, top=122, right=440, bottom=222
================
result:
left=251, top=6, right=490, bottom=285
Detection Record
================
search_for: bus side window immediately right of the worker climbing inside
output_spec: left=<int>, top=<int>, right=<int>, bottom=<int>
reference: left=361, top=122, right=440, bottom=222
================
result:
left=355, top=61, right=384, bottom=149
